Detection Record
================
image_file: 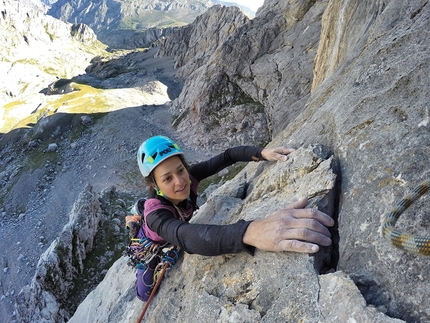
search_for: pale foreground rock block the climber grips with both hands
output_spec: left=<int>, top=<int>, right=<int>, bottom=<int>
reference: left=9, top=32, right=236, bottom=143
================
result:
left=70, top=145, right=336, bottom=322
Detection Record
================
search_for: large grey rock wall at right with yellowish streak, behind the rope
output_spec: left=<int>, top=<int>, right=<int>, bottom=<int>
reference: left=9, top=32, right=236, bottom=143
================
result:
left=282, top=1, right=430, bottom=322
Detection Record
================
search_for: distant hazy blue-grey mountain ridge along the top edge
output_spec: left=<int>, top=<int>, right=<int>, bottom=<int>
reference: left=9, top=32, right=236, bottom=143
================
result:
left=47, top=0, right=254, bottom=49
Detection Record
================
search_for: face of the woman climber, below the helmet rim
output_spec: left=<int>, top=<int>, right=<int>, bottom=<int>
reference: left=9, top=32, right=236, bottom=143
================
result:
left=154, top=156, right=190, bottom=205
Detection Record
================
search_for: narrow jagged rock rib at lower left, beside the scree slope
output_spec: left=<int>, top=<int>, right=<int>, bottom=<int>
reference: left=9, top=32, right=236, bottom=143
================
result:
left=17, top=186, right=102, bottom=322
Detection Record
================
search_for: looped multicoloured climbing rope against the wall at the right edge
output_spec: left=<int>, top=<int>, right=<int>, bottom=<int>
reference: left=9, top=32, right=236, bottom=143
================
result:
left=381, top=179, right=430, bottom=256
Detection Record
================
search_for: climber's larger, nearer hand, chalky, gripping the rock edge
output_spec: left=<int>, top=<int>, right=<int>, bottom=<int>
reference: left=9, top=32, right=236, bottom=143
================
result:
left=243, top=198, right=334, bottom=253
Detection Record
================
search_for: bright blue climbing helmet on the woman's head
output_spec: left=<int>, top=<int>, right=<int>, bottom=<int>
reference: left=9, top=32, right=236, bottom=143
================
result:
left=137, top=136, right=184, bottom=177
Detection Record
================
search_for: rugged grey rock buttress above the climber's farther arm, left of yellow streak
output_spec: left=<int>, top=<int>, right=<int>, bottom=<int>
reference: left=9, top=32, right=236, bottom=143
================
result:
left=159, top=1, right=325, bottom=148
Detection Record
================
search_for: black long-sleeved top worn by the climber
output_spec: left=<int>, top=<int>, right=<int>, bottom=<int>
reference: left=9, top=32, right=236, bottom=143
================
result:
left=146, top=146, right=263, bottom=256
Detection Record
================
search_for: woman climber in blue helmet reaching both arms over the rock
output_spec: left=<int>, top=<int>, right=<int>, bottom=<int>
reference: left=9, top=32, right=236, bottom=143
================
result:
left=136, top=136, right=334, bottom=301
